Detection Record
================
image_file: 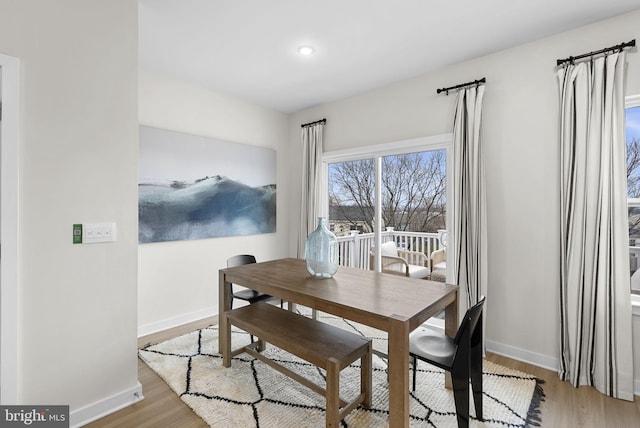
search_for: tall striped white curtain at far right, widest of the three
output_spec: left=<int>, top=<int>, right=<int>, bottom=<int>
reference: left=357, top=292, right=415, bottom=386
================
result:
left=558, top=52, right=633, bottom=400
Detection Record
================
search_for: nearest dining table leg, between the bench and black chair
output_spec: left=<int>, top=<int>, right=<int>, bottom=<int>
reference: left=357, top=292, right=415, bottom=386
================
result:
left=388, top=317, right=409, bottom=428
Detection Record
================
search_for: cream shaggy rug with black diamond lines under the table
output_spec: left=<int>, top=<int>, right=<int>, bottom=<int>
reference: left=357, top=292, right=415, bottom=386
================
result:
left=139, top=314, right=544, bottom=428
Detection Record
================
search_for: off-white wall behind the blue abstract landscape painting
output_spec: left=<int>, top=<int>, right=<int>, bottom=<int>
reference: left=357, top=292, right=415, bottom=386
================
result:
left=138, top=70, right=291, bottom=335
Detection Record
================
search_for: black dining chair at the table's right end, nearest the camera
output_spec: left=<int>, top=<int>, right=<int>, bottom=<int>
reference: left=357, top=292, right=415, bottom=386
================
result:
left=409, top=296, right=485, bottom=428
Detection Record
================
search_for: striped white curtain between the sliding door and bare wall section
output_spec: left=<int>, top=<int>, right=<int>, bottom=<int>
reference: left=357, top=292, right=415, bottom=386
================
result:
left=447, top=86, right=487, bottom=313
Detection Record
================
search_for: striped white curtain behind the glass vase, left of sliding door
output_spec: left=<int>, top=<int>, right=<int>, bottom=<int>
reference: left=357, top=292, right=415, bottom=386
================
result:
left=298, top=122, right=326, bottom=259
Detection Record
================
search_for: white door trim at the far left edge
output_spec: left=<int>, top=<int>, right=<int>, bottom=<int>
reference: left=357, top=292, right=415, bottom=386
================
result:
left=0, top=54, right=20, bottom=405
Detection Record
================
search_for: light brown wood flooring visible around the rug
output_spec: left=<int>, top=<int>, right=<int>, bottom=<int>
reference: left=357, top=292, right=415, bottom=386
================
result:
left=85, top=317, right=640, bottom=428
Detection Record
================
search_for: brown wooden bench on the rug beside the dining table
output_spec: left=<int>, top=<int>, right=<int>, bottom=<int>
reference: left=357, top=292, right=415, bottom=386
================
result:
left=224, top=302, right=372, bottom=427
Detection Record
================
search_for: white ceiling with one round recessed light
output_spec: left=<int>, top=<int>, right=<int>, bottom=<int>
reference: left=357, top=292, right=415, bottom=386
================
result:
left=139, top=0, right=640, bottom=113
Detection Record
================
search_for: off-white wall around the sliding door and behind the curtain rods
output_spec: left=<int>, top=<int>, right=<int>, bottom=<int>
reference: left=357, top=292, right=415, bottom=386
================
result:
left=289, top=11, right=640, bottom=378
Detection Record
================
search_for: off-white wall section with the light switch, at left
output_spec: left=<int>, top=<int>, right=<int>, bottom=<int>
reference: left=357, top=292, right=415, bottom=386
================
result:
left=0, top=0, right=139, bottom=424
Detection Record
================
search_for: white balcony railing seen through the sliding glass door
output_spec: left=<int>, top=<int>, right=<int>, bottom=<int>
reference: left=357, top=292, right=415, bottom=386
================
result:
left=338, top=227, right=441, bottom=269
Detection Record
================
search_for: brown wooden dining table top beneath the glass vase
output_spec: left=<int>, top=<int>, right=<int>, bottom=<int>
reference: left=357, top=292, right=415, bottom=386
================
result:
left=221, top=258, right=458, bottom=330
